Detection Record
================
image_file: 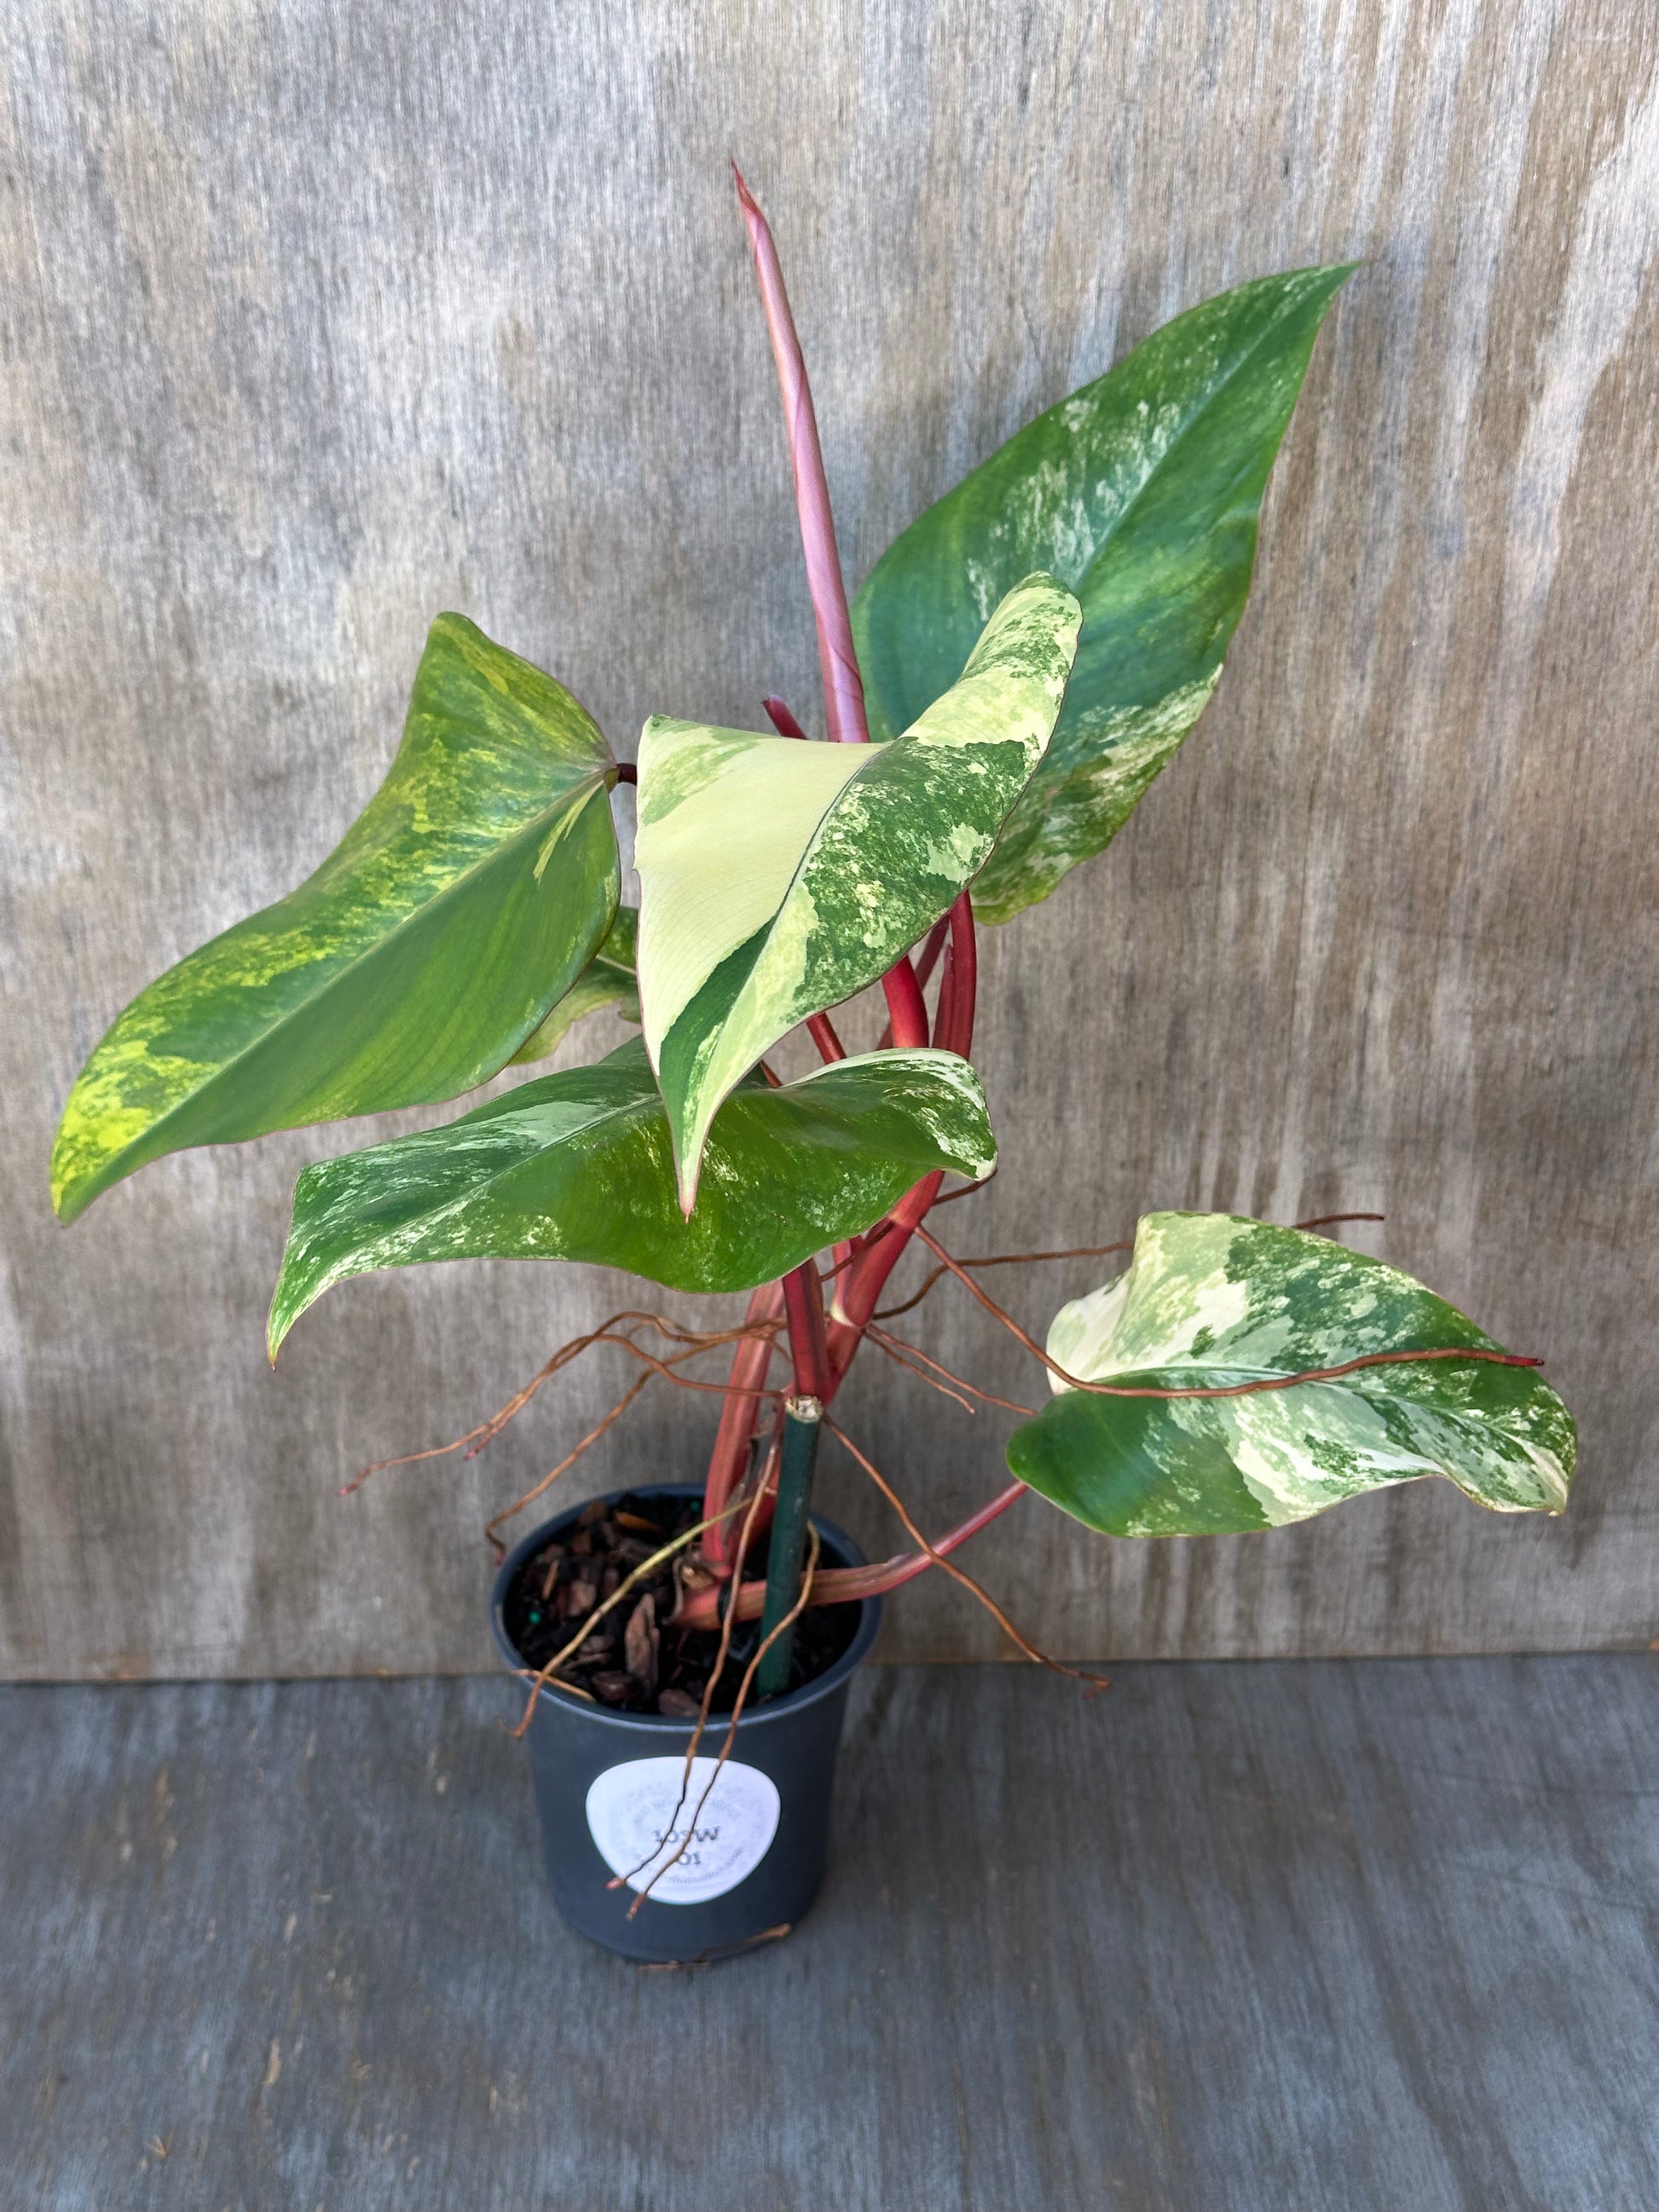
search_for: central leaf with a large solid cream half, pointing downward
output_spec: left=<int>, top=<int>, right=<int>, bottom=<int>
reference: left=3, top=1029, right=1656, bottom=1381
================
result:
left=635, top=575, right=1078, bottom=1210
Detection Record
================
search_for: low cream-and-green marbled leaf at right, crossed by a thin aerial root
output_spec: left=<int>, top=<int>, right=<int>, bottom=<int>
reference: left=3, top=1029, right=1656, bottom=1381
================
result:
left=1009, top=1215, right=1577, bottom=1535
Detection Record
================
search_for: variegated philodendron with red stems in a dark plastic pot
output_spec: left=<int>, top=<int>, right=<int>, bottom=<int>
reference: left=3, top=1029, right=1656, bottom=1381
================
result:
left=53, top=177, right=1575, bottom=1960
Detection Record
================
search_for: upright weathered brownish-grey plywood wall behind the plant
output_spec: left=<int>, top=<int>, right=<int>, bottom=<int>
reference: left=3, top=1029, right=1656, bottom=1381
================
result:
left=0, top=0, right=1659, bottom=1677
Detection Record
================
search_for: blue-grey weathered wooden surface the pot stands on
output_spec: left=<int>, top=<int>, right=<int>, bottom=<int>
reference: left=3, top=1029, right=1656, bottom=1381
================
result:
left=0, top=1657, right=1659, bottom=2212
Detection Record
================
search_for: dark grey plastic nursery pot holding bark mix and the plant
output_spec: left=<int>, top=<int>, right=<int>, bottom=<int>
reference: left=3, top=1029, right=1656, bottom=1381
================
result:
left=488, top=1482, right=881, bottom=1964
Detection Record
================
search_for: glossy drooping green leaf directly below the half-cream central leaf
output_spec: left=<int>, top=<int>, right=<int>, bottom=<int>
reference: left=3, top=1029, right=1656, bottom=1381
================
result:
left=270, top=1040, right=996, bottom=1358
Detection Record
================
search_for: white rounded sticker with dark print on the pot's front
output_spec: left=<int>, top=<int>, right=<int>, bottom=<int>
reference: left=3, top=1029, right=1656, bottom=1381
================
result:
left=588, top=1754, right=778, bottom=1904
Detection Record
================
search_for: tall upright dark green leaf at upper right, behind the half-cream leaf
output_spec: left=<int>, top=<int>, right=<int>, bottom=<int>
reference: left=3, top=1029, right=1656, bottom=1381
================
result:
left=852, top=263, right=1354, bottom=922
